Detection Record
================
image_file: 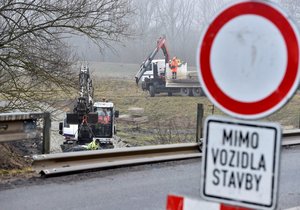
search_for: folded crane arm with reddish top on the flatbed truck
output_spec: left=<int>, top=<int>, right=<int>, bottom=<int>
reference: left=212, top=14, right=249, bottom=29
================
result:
left=135, top=36, right=169, bottom=84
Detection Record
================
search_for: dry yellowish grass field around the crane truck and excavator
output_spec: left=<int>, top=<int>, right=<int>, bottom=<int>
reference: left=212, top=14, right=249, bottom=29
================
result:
left=84, top=63, right=300, bottom=146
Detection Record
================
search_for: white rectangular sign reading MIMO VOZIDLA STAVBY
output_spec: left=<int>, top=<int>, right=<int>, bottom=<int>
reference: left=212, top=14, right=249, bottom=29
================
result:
left=201, top=116, right=281, bottom=209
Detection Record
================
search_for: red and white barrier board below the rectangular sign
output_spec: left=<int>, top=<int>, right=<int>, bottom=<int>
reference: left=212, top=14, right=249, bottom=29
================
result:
left=166, top=195, right=250, bottom=210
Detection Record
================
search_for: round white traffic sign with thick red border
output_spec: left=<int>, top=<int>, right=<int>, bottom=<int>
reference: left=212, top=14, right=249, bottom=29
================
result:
left=197, top=0, right=299, bottom=119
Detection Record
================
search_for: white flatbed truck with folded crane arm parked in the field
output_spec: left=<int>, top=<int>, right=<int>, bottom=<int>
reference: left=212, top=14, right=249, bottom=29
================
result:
left=135, top=36, right=204, bottom=97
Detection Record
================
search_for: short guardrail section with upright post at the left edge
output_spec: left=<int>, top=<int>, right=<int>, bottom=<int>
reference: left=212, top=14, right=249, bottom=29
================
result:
left=0, top=112, right=51, bottom=154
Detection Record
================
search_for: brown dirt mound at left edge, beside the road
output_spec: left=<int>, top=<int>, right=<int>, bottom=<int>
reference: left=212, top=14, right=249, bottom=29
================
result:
left=0, top=144, right=30, bottom=170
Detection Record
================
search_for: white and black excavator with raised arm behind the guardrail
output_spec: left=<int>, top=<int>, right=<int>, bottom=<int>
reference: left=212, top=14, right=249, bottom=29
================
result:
left=59, top=66, right=119, bottom=151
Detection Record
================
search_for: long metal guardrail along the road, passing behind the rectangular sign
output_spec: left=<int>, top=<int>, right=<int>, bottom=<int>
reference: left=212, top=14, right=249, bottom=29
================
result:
left=33, top=130, right=300, bottom=176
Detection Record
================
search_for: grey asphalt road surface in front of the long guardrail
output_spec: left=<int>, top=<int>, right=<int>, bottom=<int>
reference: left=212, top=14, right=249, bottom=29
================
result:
left=0, top=146, right=300, bottom=210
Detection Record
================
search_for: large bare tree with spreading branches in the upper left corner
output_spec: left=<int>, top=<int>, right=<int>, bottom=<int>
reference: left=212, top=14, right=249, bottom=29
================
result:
left=0, top=0, right=131, bottom=112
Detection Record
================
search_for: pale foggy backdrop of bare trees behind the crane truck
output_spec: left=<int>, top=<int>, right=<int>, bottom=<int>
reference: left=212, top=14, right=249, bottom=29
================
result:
left=69, top=0, right=300, bottom=66
